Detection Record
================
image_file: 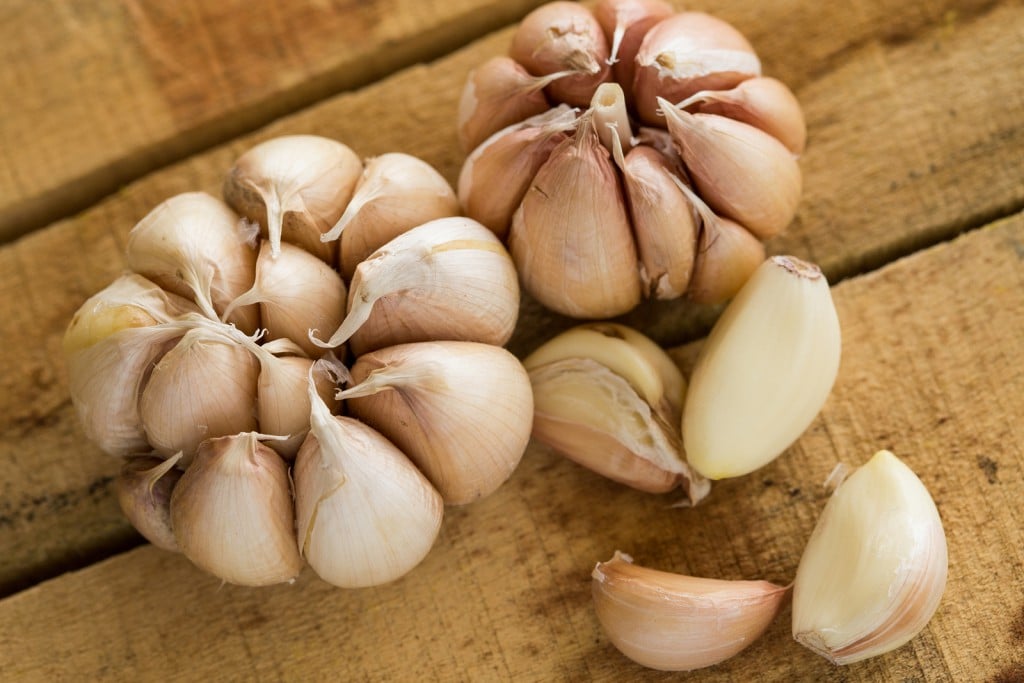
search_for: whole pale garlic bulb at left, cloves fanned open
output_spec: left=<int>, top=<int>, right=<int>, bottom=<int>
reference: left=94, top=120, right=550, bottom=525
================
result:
left=63, top=135, right=532, bottom=587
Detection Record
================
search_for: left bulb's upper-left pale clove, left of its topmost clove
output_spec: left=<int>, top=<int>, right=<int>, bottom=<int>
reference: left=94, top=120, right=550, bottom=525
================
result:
left=126, top=193, right=259, bottom=333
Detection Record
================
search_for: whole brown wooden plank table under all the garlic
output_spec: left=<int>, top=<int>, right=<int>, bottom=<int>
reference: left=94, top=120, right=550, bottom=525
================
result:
left=0, top=0, right=1024, bottom=681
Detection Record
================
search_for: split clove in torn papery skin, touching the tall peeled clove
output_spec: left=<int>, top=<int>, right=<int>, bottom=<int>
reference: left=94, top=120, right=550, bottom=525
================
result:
left=523, top=323, right=710, bottom=504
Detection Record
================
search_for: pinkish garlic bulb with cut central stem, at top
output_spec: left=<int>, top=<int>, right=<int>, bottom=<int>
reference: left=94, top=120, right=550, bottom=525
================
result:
left=459, top=0, right=806, bottom=318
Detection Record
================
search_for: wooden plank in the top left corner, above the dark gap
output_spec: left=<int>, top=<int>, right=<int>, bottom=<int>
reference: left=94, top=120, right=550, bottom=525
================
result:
left=0, top=0, right=542, bottom=241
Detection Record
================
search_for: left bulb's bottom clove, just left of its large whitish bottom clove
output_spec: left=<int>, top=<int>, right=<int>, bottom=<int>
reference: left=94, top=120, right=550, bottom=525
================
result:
left=171, top=432, right=302, bottom=586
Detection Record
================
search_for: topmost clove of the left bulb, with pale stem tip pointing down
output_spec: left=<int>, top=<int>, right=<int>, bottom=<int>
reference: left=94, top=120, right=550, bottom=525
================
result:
left=223, top=135, right=362, bottom=263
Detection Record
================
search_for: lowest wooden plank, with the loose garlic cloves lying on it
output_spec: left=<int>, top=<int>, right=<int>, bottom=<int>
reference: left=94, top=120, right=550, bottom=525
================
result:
left=0, top=214, right=1024, bottom=683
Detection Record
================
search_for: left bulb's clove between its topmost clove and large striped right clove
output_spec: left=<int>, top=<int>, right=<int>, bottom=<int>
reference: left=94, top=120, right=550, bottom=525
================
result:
left=323, top=153, right=459, bottom=279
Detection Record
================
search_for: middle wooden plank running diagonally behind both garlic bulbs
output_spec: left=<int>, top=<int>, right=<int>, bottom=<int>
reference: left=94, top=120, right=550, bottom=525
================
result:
left=0, top=2, right=1024, bottom=591
